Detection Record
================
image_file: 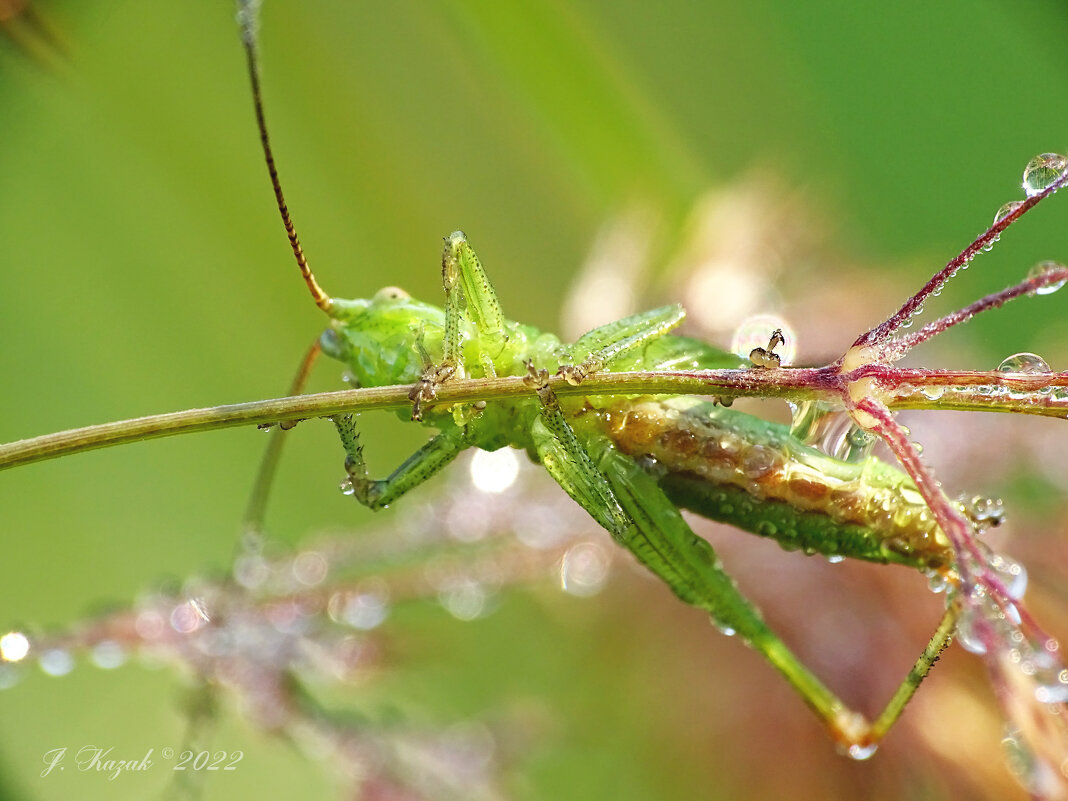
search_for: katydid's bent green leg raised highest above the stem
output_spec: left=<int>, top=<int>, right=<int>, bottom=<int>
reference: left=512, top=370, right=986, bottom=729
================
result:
left=409, top=231, right=508, bottom=420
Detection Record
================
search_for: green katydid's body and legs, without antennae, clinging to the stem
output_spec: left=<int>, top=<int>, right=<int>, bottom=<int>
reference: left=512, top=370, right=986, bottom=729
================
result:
left=320, top=232, right=956, bottom=758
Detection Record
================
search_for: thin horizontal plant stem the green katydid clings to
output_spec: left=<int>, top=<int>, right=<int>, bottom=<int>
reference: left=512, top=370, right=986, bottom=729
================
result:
left=0, top=365, right=1068, bottom=470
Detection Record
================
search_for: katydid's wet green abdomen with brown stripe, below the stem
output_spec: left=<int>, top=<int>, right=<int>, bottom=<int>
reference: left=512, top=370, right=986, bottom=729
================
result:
left=602, top=397, right=953, bottom=568
